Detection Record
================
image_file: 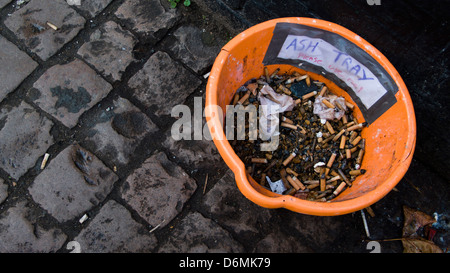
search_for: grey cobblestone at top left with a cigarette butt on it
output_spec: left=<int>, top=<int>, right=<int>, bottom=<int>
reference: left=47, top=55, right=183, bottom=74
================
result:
left=5, top=0, right=85, bottom=61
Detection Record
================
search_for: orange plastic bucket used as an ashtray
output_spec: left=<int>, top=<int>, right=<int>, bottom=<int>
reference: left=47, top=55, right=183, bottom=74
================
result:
left=205, top=18, right=416, bottom=216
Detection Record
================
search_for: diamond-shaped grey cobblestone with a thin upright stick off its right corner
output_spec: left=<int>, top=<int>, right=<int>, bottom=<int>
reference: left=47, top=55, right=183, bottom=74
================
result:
left=121, top=152, right=197, bottom=227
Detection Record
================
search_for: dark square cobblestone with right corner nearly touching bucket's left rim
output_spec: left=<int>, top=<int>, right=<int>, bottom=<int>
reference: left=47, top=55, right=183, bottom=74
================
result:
left=128, top=51, right=201, bottom=115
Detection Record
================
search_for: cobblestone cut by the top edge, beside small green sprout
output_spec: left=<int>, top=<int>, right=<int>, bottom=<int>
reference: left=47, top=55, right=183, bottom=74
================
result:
left=115, top=0, right=179, bottom=42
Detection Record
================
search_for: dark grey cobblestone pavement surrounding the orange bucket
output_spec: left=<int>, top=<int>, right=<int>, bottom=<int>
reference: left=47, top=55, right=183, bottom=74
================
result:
left=0, top=0, right=450, bottom=253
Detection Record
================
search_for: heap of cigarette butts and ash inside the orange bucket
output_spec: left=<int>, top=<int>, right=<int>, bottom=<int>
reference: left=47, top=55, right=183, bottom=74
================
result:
left=230, top=67, right=367, bottom=202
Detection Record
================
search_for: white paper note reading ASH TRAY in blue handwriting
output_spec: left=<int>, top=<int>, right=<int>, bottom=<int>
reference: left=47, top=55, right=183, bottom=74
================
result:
left=277, top=35, right=387, bottom=109
